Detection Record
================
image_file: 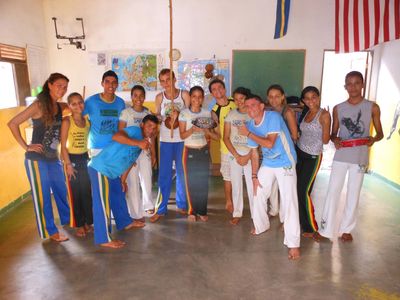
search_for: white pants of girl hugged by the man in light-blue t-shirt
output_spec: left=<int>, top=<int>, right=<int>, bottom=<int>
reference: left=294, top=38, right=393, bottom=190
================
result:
left=229, top=155, right=253, bottom=218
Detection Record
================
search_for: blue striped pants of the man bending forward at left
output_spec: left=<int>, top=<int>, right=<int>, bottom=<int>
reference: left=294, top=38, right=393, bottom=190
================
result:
left=88, top=167, right=132, bottom=244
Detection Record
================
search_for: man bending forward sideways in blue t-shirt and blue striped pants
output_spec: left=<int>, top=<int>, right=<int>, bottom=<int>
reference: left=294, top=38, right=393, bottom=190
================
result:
left=88, top=115, right=158, bottom=248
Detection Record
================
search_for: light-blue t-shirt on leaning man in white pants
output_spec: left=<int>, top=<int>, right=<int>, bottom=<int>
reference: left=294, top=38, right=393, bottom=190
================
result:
left=247, top=111, right=297, bottom=168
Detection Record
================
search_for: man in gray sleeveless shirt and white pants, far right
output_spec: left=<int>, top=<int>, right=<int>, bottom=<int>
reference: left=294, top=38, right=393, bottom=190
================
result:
left=316, top=71, right=383, bottom=242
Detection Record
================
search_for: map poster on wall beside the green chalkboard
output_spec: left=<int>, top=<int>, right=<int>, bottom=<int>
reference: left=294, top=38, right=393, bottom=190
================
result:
left=178, top=59, right=230, bottom=100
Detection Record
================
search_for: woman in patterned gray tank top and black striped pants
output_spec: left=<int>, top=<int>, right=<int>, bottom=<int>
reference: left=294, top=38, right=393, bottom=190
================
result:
left=296, top=86, right=331, bottom=241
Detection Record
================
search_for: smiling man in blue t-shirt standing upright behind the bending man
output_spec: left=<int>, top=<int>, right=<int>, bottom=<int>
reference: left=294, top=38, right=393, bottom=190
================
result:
left=83, top=70, right=140, bottom=247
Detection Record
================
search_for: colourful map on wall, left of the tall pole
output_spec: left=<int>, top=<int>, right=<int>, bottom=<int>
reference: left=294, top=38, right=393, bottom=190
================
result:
left=109, top=53, right=163, bottom=92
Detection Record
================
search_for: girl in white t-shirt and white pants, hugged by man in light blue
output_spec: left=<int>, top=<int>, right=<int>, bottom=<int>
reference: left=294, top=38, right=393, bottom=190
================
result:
left=223, top=87, right=253, bottom=225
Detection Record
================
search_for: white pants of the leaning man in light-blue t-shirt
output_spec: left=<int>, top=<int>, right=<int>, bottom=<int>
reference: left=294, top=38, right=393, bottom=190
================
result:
left=253, top=166, right=300, bottom=248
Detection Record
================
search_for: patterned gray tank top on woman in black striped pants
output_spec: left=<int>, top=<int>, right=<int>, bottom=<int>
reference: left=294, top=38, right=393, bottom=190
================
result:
left=297, top=109, right=323, bottom=155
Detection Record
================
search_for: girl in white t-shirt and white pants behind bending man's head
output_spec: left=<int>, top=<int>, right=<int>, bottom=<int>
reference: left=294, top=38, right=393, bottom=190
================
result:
left=118, top=85, right=156, bottom=227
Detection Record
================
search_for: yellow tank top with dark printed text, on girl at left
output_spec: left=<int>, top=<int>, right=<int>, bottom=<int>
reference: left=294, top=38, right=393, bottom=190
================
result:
left=67, top=117, right=90, bottom=154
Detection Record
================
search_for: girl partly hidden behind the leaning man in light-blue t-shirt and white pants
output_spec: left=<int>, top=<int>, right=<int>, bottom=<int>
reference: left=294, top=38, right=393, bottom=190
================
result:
left=267, top=84, right=299, bottom=221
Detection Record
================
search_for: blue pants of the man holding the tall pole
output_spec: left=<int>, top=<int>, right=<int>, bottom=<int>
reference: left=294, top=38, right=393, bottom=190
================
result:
left=156, top=142, right=187, bottom=215
